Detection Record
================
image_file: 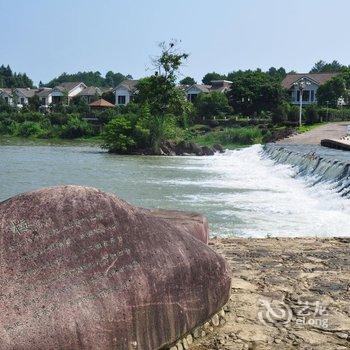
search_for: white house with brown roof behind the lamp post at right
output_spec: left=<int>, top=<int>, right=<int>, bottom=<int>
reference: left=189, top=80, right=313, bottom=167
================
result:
left=282, top=73, right=338, bottom=105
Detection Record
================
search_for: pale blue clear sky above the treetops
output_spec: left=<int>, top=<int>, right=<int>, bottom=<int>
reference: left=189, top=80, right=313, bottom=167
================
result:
left=0, top=0, right=350, bottom=84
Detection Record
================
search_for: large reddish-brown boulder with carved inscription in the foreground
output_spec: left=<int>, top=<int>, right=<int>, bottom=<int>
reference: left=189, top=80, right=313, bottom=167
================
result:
left=0, top=186, right=230, bottom=350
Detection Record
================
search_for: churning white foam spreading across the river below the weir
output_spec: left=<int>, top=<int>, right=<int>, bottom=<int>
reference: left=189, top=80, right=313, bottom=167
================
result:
left=167, top=145, right=350, bottom=237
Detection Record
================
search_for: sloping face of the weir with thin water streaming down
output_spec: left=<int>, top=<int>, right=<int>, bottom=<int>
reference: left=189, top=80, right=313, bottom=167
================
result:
left=263, top=144, right=350, bottom=198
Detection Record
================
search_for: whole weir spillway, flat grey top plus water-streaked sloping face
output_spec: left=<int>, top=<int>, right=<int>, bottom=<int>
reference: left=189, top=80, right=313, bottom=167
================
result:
left=263, top=144, right=350, bottom=199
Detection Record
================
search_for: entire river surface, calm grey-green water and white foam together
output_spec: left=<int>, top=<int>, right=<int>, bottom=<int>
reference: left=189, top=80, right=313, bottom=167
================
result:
left=0, top=145, right=350, bottom=237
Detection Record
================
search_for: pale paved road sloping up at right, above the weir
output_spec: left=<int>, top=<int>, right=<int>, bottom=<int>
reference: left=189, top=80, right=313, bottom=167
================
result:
left=277, top=121, right=350, bottom=145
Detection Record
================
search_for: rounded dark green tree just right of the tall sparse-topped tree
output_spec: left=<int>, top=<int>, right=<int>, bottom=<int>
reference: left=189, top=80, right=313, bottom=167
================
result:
left=195, top=91, right=232, bottom=119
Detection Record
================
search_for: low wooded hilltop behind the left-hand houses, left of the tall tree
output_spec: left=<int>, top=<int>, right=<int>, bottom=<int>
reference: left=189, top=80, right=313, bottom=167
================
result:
left=45, top=71, right=132, bottom=87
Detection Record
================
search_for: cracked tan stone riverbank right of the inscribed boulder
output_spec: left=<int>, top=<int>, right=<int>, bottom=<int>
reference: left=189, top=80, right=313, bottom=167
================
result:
left=191, top=238, right=350, bottom=350
